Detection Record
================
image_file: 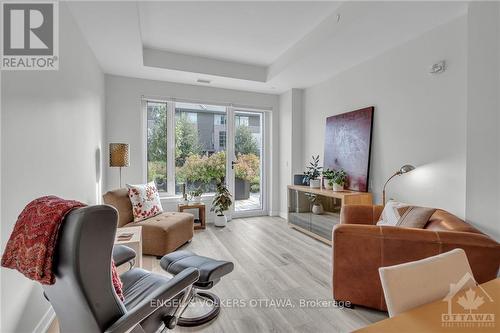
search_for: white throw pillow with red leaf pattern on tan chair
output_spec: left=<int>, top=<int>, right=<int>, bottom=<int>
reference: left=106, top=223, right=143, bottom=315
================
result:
left=127, top=182, right=163, bottom=222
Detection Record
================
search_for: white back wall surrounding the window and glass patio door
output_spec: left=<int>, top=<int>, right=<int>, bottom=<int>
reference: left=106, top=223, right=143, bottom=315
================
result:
left=105, top=75, right=279, bottom=215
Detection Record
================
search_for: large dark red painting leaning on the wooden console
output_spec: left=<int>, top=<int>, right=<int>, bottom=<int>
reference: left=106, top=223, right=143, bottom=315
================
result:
left=323, top=106, right=374, bottom=192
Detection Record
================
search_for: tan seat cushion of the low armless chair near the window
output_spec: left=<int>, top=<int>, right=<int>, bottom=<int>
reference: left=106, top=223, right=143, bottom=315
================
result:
left=125, top=212, right=194, bottom=256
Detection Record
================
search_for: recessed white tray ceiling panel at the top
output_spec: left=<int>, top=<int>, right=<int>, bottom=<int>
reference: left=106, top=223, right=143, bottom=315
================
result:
left=139, top=2, right=338, bottom=65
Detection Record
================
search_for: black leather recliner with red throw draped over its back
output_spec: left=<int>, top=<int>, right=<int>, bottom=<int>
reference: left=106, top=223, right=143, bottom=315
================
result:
left=43, top=205, right=199, bottom=333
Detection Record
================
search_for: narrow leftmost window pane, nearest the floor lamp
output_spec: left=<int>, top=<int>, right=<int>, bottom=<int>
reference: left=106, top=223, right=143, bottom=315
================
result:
left=146, top=101, right=167, bottom=192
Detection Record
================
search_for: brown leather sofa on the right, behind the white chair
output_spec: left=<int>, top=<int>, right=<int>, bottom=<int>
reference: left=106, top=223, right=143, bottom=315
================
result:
left=332, top=205, right=500, bottom=311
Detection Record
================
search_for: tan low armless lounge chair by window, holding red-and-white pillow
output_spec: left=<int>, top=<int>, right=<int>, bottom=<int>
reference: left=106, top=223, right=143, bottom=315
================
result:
left=103, top=189, right=194, bottom=256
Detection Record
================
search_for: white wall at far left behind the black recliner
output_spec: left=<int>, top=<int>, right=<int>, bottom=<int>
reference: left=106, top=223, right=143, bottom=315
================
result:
left=0, top=4, right=104, bottom=332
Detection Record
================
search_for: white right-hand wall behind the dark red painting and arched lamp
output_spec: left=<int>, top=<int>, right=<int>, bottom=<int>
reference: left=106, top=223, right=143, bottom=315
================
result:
left=303, top=17, right=467, bottom=217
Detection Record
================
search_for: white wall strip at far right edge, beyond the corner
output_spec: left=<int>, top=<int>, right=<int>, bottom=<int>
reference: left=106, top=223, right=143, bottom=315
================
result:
left=466, top=2, right=500, bottom=240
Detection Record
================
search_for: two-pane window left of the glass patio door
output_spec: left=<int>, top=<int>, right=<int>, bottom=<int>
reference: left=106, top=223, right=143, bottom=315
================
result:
left=145, top=101, right=227, bottom=194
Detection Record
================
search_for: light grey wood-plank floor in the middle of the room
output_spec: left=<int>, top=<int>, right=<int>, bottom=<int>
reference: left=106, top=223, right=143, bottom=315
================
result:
left=143, top=217, right=387, bottom=333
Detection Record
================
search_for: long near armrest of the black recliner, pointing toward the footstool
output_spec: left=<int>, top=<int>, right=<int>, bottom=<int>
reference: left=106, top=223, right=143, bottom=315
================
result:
left=105, top=268, right=200, bottom=333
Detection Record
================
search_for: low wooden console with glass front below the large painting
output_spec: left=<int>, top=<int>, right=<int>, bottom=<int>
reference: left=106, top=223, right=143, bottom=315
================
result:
left=288, top=185, right=373, bottom=245
